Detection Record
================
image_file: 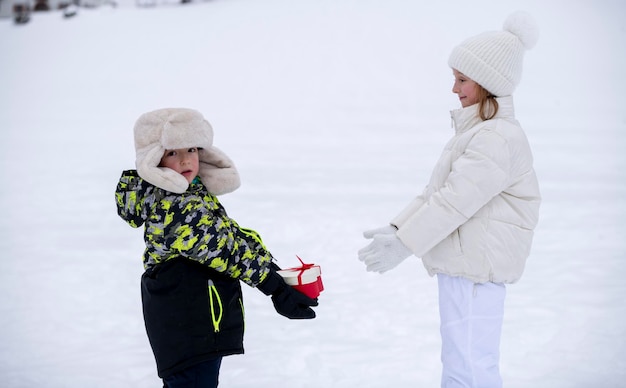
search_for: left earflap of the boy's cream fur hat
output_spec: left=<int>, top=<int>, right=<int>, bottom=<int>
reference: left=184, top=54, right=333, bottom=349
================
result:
left=136, top=144, right=189, bottom=194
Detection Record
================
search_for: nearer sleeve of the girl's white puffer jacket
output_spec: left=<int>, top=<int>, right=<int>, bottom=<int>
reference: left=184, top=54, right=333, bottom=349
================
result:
left=393, top=130, right=510, bottom=257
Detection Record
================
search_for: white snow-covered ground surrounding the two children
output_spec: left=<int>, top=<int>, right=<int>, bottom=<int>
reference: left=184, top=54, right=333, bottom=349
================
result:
left=0, top=0, right=626, bottom=388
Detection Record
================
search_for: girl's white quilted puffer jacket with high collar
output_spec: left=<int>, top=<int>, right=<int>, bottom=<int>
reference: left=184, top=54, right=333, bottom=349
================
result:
left=391, top=97, right=541, bottom=283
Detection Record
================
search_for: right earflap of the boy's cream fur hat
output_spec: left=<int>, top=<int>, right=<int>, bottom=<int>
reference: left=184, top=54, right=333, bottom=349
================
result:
left=198, top=146, right=241, bottom=195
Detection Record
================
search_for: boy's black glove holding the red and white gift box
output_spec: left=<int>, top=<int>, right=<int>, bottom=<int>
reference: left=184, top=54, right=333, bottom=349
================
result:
left=257, top=264, right=318, bottom=319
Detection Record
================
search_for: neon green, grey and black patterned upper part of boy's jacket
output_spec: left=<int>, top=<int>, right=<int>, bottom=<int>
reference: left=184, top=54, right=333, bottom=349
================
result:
left=115, top=170, right=272, bottom=287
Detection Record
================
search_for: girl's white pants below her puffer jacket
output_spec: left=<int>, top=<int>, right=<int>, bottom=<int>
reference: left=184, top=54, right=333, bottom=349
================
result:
left=437, top=274, right=506, bottom=388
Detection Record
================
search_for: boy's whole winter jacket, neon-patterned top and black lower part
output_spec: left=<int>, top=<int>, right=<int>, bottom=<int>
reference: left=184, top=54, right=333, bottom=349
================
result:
left=115, top=170, right=272, bottom=377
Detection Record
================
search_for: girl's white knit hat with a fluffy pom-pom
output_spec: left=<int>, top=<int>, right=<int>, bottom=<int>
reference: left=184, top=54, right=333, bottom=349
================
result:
left=448, top=11, right=539, bottom=97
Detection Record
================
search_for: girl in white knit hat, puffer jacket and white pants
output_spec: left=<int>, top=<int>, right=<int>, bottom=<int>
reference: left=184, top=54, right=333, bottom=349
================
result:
left=359, top=12, right=541, bottom=388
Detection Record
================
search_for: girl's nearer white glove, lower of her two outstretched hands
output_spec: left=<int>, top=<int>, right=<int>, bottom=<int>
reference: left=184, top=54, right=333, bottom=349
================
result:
left=359, top=233, right=413, bottom=273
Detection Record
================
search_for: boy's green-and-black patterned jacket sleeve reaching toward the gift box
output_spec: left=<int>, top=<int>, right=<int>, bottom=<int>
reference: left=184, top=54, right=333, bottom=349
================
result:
left=149, top=196, right=272, bottom=287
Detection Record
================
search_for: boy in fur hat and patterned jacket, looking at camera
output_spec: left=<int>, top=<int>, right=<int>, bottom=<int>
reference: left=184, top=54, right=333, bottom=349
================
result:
left=115, top=108, right=317, bottom=388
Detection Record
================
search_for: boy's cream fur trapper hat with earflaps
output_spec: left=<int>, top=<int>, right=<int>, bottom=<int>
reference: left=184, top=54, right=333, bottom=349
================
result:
left=135, top=108, right=240, bottom=195
